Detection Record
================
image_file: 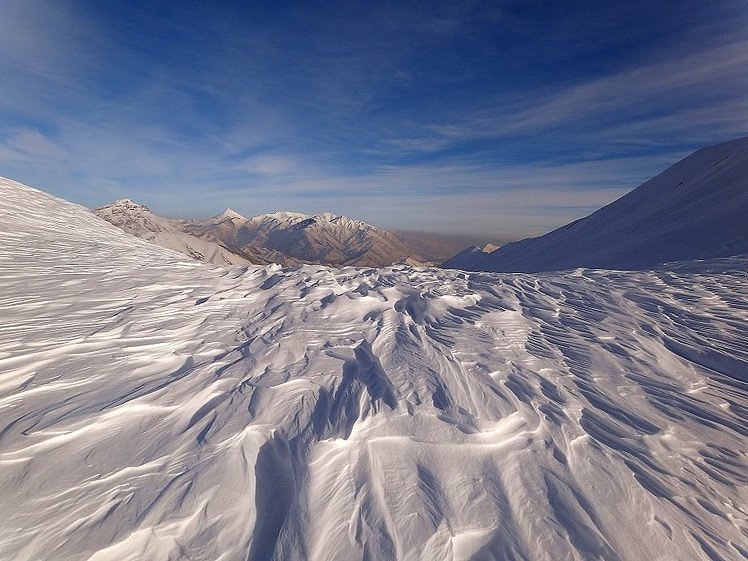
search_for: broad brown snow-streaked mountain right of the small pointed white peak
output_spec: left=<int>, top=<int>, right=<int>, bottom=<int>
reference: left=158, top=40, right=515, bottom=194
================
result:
left=236, top=212, right=420, bottom=267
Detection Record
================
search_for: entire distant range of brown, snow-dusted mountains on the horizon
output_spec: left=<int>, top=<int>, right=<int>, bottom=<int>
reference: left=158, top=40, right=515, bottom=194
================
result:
left=94, top=199, right=464, bottom=267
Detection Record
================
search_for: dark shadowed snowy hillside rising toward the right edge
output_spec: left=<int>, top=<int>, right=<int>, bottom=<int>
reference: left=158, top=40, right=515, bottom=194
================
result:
left=443, top=138, right=748, bottom=272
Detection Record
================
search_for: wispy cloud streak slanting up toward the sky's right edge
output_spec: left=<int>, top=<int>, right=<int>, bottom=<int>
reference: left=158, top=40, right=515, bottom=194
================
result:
left=389, top=40, right=748, bottom=152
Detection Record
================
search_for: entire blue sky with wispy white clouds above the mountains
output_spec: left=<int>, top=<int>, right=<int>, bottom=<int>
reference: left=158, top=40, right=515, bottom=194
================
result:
left=0, top=0, right=748, bottom=239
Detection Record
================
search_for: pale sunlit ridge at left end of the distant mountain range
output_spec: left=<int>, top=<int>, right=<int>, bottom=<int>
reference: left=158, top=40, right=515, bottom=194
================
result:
left=94, top=199, right=250, bottom=265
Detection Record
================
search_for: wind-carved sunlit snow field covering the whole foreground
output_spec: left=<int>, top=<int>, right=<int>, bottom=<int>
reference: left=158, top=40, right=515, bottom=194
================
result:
left=0, top=176, right=748, bottom=561
